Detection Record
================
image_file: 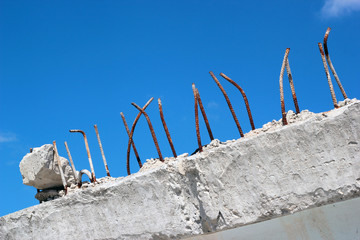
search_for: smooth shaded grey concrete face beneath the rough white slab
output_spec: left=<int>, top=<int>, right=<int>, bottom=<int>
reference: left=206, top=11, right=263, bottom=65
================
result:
left=186, top=198, right=360, bottom=240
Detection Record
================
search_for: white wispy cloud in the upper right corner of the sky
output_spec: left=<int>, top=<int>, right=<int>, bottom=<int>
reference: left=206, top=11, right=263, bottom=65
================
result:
left=321, top=0, right=360, bottom=18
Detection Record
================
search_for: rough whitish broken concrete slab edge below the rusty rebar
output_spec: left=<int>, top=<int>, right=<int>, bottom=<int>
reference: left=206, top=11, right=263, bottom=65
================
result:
left=0, top=101, right=360, bottom=239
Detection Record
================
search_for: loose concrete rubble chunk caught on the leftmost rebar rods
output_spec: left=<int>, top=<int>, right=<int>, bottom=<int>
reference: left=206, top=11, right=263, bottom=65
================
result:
left=20, top=144, right=74, bottom=189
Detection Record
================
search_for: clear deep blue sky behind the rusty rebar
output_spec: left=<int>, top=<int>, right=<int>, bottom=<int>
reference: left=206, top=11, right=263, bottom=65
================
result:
left=0, top=0, right=360, bottom=216
